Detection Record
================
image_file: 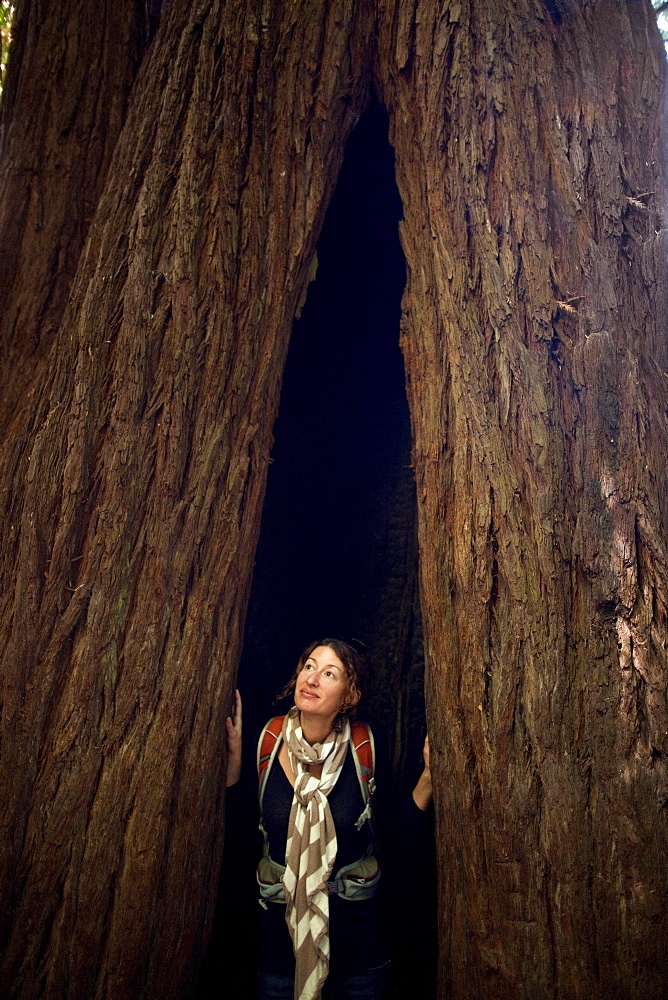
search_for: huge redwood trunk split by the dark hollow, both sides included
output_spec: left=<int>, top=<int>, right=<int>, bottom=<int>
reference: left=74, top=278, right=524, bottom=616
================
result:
left=0, top=0, right=668, bottom=1000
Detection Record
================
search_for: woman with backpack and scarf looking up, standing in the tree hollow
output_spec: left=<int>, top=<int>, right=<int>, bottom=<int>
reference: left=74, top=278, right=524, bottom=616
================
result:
left=228, top=639, right=431, bottom=1000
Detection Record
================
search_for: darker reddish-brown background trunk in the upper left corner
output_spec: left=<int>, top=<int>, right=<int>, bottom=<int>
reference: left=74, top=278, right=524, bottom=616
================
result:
left=0, top=0, right=151, bottom=436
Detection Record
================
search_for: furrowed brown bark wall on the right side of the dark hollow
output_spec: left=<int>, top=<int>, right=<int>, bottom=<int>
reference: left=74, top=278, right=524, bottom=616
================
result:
left=379, top=2, right=668, bottom=1000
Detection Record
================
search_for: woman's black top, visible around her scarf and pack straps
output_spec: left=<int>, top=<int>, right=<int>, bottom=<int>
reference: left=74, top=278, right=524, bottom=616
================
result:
left=260, top=748, right=388, bottom=976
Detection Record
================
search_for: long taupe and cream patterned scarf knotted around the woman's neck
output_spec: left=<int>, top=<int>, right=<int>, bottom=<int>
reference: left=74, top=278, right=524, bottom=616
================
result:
left=283, top=706, right=350, bottom=1000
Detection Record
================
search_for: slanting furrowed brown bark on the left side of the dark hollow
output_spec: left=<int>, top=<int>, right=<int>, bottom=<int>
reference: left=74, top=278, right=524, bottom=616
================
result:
left=0, top=0, right=369, bottom=1000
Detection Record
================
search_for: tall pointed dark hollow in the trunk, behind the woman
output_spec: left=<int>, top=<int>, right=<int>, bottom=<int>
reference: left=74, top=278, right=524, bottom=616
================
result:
left=199, top=106, right=435, bottom=1000
